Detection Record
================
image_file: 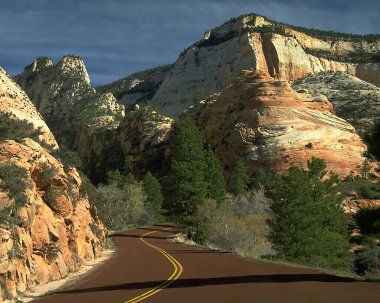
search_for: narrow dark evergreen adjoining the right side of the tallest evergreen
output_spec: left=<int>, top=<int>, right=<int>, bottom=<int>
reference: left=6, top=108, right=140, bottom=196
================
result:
left=205, top=144, right=226, bottom=202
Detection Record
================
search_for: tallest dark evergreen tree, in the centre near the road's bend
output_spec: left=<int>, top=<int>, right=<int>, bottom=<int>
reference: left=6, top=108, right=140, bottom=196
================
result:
left=165, top=119, right=207, bottom=225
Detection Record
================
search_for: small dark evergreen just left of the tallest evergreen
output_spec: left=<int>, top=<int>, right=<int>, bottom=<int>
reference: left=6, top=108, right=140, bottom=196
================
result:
left=143, top=172, right=164, bottom=222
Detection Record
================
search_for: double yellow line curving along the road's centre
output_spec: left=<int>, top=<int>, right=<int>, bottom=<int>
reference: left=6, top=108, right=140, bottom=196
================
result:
left=124, top=228, right=183, bottom=303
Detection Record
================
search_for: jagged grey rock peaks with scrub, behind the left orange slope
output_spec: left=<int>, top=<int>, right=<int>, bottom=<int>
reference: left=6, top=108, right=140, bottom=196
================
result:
left=15, top=55, right=124, bottom=149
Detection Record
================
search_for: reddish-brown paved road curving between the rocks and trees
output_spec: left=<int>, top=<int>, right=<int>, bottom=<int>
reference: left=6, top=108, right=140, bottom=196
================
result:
left=35, top=226, right=380, bottom=303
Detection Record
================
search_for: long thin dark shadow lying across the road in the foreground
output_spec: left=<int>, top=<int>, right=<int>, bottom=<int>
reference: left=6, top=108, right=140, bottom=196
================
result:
left=57, top=274, right=357, bottom=294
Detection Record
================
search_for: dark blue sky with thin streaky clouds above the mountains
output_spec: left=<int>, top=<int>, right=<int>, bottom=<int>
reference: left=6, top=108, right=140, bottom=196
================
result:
left=0, top=0, right=380, bottom=86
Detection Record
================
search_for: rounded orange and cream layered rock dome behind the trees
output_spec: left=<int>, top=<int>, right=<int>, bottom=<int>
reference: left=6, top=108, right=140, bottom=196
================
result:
left=184, top=71, right=366, bottom=177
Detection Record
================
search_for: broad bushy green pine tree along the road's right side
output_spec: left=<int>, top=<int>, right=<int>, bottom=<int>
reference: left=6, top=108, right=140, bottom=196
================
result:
left=269, top=158, right=351, bottom=268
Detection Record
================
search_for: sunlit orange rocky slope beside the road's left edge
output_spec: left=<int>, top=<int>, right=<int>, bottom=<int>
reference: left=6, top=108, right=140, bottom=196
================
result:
left=0, top=65, right=105, bottom=301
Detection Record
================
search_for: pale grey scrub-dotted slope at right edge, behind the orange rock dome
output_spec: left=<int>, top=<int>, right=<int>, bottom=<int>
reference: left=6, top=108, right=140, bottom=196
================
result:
left=292, top=72, right=380, bottom=135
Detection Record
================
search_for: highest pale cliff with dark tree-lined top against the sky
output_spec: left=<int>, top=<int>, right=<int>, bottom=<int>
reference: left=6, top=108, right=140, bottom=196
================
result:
left=152, top=14, right=380, bottom=116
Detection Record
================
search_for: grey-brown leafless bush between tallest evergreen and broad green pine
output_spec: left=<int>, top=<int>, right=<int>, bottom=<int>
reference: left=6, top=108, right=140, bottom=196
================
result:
left=198, top=189, right=273, bottom=257
